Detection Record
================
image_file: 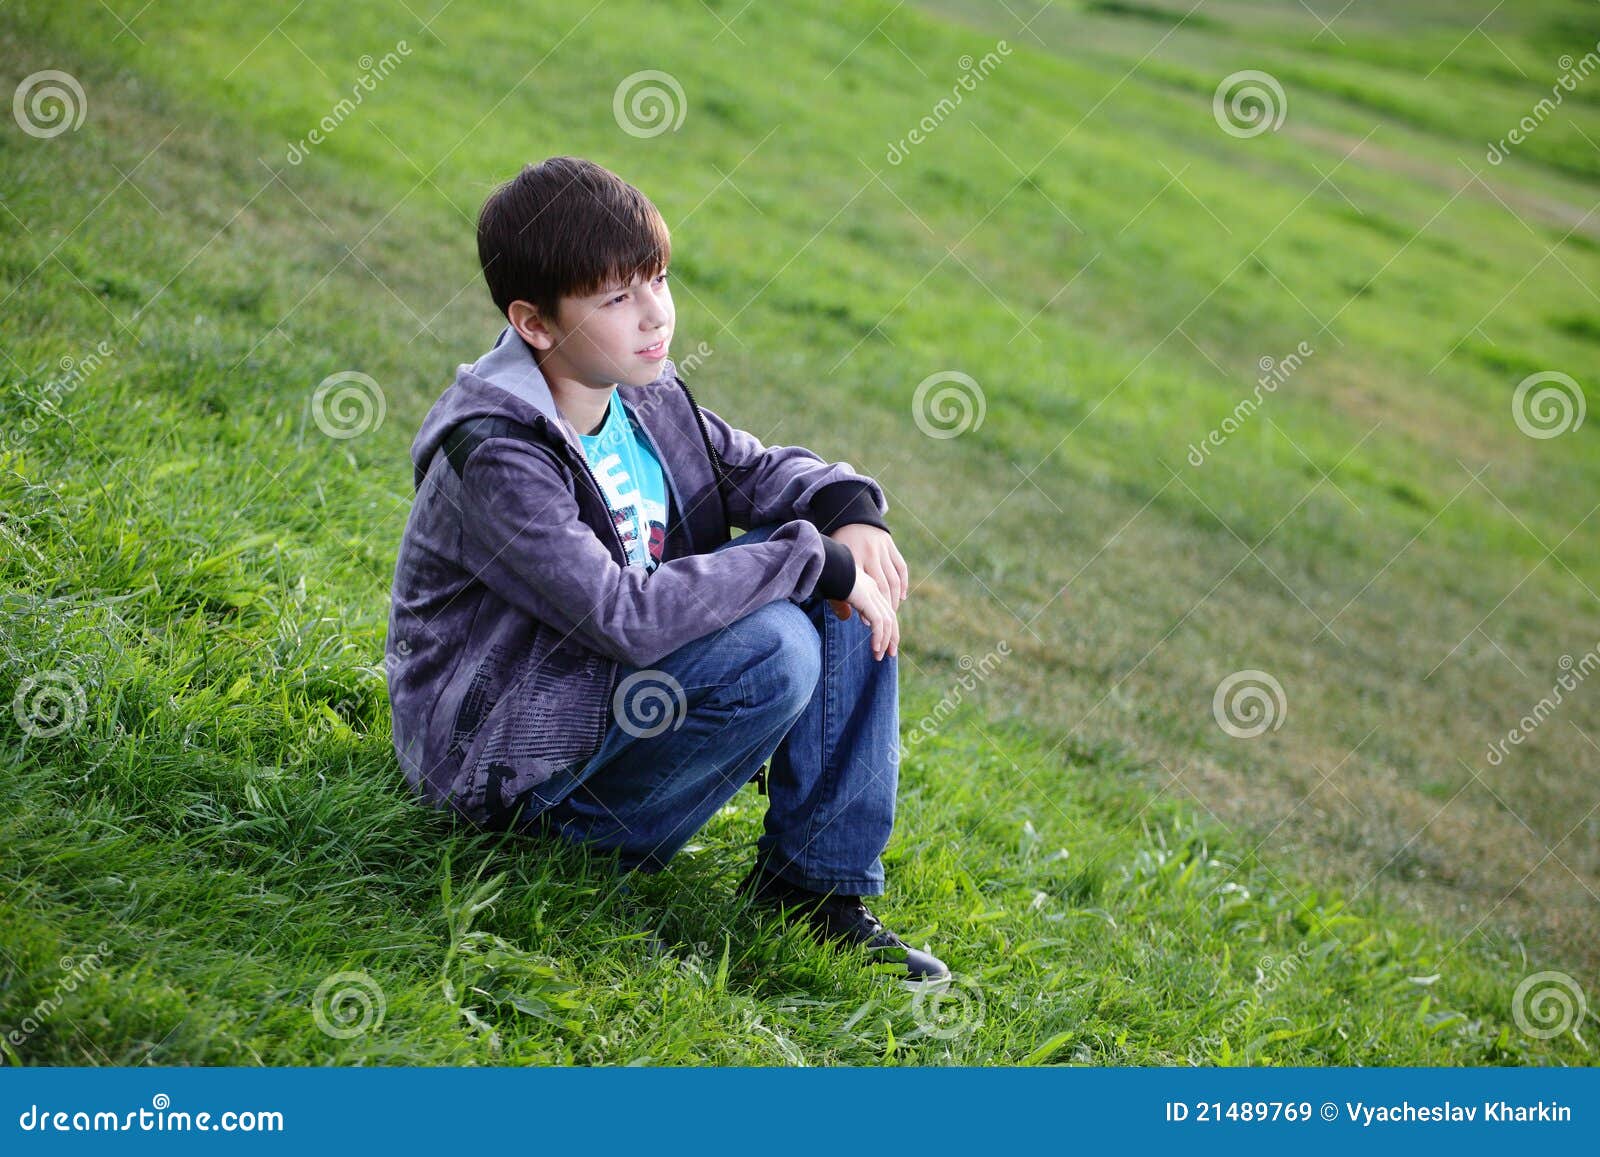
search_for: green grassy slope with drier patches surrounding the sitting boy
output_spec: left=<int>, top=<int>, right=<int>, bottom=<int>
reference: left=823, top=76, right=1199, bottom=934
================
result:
left=0, top=0, right=1600, bottom=1064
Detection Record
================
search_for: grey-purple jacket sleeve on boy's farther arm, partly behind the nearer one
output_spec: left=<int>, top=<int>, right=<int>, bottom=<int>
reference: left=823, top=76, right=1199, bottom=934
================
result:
left=701, top=406, right=890, bottom=533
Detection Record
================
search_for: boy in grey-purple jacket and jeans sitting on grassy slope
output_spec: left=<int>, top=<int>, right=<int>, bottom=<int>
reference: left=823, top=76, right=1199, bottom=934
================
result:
left=386, top=157, right=949, bottom=983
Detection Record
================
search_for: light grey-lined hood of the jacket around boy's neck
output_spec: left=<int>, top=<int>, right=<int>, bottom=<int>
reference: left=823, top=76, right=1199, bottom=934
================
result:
left=411, top=323, right=677, bottom=486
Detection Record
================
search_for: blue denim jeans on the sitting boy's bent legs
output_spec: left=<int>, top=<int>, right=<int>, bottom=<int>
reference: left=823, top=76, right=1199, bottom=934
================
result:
left=520, top=525, right=899, bottom=896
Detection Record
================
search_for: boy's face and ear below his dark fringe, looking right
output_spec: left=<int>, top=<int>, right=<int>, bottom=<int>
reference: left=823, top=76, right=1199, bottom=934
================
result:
left=509, top=270, right=677, bottom=389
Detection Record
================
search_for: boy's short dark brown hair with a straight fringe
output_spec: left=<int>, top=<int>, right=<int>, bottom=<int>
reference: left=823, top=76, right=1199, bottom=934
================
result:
left=478, top=157, right=672, bottom=318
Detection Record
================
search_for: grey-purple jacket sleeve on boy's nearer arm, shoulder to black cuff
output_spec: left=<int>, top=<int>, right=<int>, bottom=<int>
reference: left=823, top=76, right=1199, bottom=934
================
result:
left=461, top=438, right=856, bottom=667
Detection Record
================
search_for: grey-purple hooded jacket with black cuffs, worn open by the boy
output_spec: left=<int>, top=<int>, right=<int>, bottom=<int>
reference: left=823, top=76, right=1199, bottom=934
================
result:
left=384, top=325, right=888, bottom=827
